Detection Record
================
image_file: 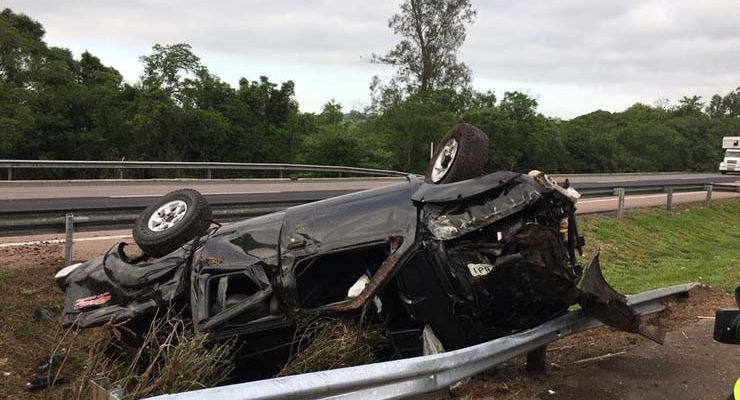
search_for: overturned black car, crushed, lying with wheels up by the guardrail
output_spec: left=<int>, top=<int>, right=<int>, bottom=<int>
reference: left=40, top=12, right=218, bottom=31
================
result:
left=57, top=125, right=661, bottom=376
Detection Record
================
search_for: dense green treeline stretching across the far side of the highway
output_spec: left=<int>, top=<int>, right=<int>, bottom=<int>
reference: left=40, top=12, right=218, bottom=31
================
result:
left=0, top=9, right=740, bottom=178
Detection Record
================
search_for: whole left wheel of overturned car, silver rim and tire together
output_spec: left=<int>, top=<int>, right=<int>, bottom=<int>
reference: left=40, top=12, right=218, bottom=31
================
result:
left=133, top=189, right=211, bottom=257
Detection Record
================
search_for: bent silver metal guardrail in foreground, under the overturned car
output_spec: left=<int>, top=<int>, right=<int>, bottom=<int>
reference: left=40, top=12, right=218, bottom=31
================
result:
left=137, top=284, right=696, bottom=400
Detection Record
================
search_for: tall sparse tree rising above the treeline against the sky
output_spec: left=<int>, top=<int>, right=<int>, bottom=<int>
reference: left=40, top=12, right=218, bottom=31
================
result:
left=371, top=0, right=476, bottom=104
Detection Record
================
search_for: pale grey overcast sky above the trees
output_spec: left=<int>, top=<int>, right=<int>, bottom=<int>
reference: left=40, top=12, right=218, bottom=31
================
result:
left=3, top=0, right=740, bottom=118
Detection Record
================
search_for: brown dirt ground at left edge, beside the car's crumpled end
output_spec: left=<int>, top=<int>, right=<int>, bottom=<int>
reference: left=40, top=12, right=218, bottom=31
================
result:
left=0, top=239, right=131, bottom=399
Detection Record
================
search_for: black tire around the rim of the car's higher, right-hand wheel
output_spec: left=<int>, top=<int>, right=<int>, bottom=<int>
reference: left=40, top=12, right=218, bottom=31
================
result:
left=424, top=124, right=488, bottom=184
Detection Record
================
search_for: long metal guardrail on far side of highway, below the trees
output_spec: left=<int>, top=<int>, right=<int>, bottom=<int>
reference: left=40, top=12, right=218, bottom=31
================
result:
left=0, top=160, right=408, bottom=180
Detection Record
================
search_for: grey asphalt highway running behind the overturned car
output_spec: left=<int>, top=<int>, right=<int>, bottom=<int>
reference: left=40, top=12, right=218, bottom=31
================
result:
left=0, top=173, right=740, bottom=212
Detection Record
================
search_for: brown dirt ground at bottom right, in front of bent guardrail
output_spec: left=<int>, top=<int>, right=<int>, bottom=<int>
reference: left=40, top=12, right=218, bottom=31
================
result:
left=453, top=287, right=740, bottom=400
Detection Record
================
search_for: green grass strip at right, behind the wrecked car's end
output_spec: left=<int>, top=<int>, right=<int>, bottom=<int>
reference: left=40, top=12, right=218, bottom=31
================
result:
left=580, top=200, right=740, bottom=293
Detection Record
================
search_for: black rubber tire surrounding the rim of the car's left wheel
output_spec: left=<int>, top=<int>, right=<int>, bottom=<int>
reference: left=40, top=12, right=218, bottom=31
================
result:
left=133, top=189, right=211, bottom=257
